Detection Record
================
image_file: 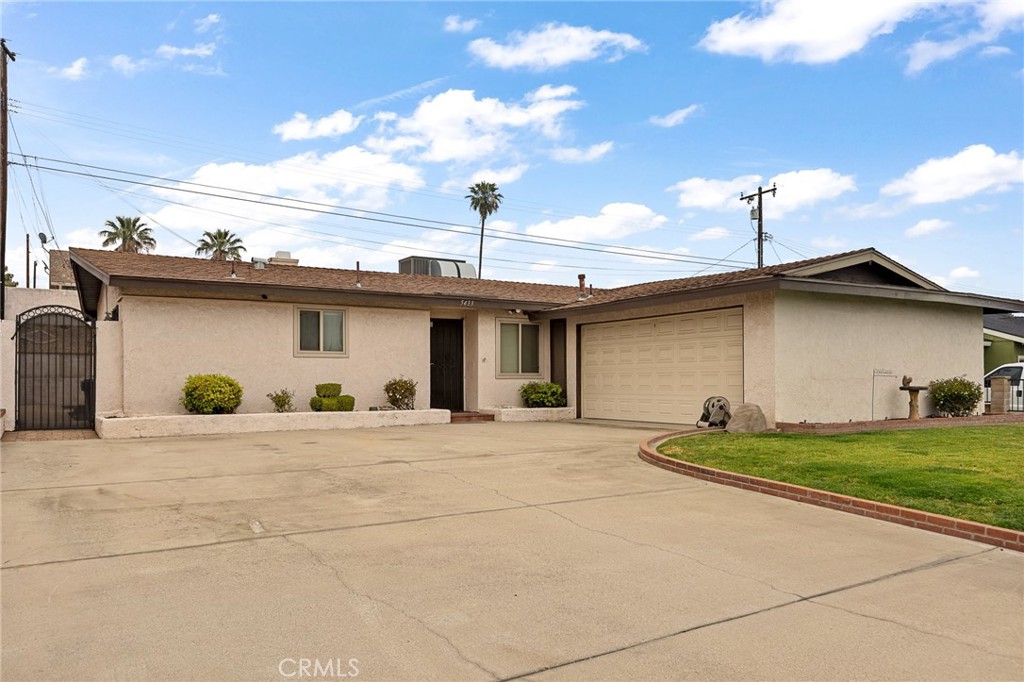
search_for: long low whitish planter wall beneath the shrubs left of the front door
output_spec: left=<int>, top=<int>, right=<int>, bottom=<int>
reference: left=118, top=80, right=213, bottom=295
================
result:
left=96, top=410, right=452, bottom=438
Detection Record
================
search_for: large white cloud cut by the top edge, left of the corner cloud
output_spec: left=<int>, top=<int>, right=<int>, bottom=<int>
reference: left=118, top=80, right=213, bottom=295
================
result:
left=699, top=0, right=929, bottom=63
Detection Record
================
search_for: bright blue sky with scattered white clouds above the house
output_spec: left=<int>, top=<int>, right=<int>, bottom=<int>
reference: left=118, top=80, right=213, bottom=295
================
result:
left=0, top=0, right=1024, bottom=298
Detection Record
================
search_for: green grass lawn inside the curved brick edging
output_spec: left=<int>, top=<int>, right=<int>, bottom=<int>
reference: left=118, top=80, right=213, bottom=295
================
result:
left=658, top=424, right=1024, bottom=530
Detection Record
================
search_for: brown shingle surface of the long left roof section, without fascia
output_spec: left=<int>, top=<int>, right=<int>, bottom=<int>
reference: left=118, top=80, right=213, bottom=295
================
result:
left=71, top=248, right=579, bottom=305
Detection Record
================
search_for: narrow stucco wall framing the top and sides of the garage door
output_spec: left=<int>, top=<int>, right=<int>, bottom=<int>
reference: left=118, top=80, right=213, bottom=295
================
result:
left=566, top=292, right=775, bottom=423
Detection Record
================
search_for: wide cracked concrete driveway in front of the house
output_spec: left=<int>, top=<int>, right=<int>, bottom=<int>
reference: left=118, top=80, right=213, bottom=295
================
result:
left=0, top=423, right=1024, bottom=682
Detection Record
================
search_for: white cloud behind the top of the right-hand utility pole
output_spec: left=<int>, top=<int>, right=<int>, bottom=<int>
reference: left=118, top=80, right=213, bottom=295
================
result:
left=668, top=168, right=857, bottom=217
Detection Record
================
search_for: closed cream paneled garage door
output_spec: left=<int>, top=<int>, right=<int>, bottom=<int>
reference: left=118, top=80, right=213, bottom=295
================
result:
left=581, top=308, right=743, bottom=424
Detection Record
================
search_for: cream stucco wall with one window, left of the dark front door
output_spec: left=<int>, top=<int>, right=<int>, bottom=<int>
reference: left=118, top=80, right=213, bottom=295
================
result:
left=120, top=295, right=430, bottom=416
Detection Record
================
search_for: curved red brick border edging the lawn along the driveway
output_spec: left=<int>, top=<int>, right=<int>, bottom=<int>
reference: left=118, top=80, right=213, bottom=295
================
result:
left=639, top=429, right=1024, bottom=552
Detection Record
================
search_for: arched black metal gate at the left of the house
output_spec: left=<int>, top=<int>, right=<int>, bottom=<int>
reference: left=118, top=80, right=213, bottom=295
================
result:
left=14, top=305, right=96, bottom=431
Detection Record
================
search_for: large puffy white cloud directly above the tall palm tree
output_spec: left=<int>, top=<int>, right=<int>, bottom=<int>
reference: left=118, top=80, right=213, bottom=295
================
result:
left=366, top=85, right=584, bottom=163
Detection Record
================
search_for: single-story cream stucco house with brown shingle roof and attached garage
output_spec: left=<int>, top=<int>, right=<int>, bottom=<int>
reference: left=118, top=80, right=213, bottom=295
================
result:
left=6, top=244, right=1024, bottom=424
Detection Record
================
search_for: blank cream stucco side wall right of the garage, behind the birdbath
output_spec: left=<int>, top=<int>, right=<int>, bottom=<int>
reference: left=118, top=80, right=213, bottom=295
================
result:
left=775, top=292, right=982, bottom=422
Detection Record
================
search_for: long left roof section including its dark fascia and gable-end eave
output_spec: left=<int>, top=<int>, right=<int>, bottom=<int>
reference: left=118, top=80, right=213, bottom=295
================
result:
left=71, top=248, right=579, bottom=316
